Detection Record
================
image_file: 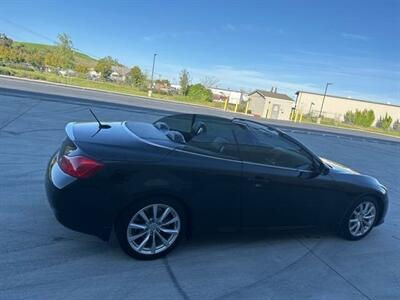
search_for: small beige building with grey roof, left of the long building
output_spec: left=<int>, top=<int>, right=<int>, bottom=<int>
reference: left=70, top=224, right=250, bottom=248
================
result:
left=249, top=88, right=294, bottom=120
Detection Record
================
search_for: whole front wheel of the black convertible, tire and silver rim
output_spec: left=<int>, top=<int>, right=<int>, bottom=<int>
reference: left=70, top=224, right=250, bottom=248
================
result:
left=340, top=197, right=378, bottom=241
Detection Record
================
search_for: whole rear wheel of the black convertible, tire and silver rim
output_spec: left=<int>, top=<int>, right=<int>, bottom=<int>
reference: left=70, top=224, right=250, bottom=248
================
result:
left=116, top=199, right=186, bottom=260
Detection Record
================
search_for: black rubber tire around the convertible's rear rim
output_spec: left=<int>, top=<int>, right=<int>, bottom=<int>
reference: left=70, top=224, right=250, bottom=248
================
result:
left=115, top=197, right=187, bottom=260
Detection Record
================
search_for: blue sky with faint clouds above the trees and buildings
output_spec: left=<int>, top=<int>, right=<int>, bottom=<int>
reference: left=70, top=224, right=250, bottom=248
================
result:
left=0, top=0, right=400, bottom=104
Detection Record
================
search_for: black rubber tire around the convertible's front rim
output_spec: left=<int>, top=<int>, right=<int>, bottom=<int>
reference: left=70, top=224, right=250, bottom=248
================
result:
left=339, top=197, right=379, bottom=241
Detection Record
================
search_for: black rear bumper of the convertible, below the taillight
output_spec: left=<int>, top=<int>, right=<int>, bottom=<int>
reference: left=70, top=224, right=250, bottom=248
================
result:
left=45, top=157, right=112, bottom=240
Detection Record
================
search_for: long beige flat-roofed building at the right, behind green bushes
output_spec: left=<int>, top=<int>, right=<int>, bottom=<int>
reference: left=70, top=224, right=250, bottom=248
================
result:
left=296, top=91, right=400, bottom=125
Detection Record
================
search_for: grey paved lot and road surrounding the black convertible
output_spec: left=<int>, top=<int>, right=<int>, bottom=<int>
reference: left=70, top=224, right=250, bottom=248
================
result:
left=0, top=79, right=400, bottom=299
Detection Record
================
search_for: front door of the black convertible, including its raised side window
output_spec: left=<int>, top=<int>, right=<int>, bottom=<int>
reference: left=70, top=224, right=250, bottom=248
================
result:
left=235, top=125, right=330, bottom=227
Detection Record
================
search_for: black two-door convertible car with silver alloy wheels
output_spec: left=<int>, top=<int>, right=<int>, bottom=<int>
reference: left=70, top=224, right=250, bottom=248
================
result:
left=46, top=114, right=388, bottom=259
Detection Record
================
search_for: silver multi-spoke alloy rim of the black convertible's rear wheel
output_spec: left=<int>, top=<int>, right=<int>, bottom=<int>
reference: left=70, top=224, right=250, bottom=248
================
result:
left=127, top=204, right=181, bottom=255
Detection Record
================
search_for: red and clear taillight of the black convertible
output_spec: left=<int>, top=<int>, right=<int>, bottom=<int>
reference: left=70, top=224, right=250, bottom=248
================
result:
left=59, top=155, right=104, bottom=179
